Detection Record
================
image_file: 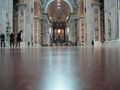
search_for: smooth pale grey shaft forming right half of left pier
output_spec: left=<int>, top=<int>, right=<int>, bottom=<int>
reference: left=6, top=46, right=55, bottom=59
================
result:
left=24, top=0, right=34, bottom=43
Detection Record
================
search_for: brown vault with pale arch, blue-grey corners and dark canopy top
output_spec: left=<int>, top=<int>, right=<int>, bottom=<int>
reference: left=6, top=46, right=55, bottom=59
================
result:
left=41, top=0, right=77, bottom=28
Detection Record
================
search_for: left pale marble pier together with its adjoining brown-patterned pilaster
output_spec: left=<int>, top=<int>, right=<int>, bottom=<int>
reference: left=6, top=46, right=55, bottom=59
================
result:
left=18, top=0, right=40, bottom=44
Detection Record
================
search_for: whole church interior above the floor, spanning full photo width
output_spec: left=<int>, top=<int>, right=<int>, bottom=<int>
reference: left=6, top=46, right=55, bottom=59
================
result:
left=0, top=0, right=120, bottom=46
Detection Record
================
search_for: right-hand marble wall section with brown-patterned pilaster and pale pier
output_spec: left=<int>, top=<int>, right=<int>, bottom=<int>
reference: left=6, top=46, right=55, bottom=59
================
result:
left=77, top=0, right=101, bottom=45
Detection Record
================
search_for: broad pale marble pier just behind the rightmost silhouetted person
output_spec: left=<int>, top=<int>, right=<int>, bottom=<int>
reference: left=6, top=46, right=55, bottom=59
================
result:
left=18, top=0, right=34, bottom=45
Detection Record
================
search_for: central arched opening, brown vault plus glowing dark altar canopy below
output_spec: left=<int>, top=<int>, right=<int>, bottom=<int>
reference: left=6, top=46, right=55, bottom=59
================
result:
left=47, top=0, right=71, bottom=43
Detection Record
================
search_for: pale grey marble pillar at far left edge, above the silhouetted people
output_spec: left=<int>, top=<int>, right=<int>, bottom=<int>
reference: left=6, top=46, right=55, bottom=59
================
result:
left=0, top=0, right=13, bottom=41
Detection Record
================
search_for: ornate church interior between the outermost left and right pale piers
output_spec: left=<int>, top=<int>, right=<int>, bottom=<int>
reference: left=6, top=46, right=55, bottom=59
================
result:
left=13, top=0, right=107, bottom=46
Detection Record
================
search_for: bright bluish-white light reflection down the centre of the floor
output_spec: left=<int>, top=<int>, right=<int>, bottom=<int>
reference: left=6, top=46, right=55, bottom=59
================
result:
left=40, top=48, right=77, bottom=90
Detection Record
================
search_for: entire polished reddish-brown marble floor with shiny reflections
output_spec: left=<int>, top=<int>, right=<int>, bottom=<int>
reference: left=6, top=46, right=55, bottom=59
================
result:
left=0, top=47, right=120, bottom=90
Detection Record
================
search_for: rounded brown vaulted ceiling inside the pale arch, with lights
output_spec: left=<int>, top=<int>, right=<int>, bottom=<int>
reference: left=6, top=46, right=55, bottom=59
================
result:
left=47, top=0, right=71, bottom=22
